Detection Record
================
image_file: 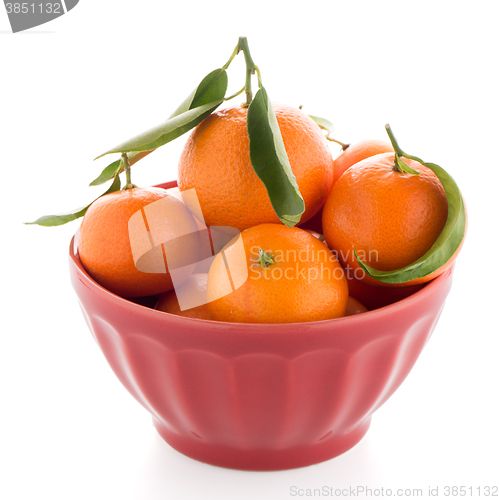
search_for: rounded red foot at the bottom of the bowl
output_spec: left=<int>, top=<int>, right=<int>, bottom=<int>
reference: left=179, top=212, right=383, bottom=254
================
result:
left=153, top=417, right=371, bottom=471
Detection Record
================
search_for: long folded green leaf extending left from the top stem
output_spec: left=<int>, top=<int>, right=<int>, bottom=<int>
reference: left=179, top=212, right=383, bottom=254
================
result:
left=96, top=70, right=227, bottom=159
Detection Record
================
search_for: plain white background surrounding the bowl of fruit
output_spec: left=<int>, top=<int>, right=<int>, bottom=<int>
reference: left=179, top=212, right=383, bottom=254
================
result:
left=0, top=0, right=500, bottom=500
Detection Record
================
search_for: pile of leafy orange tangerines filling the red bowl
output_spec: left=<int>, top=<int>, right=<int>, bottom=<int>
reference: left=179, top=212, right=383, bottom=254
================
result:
left=30, top=39, right=466, bottom=323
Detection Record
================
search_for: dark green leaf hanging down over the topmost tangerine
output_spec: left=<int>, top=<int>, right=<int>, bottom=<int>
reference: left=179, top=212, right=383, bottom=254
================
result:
left=247, top=87, right=305, bottom=227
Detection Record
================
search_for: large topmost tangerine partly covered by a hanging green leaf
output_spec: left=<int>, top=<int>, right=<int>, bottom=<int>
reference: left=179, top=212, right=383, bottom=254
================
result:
left=178, top=104, right=333, bottom=231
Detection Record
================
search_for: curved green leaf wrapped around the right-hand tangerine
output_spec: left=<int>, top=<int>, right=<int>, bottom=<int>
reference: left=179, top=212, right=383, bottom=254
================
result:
left=355, top=158, right=466, bottom=283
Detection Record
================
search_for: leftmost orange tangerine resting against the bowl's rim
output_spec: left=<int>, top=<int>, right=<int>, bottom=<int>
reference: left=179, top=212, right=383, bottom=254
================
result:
left=78, top=187, right=199, bottom=298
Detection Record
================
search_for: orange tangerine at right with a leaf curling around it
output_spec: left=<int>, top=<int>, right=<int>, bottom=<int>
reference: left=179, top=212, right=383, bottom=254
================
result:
left=323, top=153, right=448, bottom=286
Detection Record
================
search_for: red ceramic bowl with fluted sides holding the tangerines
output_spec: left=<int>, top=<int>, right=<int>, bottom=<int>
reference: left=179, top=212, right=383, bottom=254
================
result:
left=70, top=183, right=453, bottom=470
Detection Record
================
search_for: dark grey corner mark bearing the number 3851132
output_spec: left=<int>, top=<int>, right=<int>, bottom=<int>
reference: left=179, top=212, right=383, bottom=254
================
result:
left=4, top=0, right=79, bottom=33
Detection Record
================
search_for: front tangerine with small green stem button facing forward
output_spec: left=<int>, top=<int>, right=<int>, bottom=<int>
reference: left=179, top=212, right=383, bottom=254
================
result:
left=207, top=224, right=349, bottom=323
